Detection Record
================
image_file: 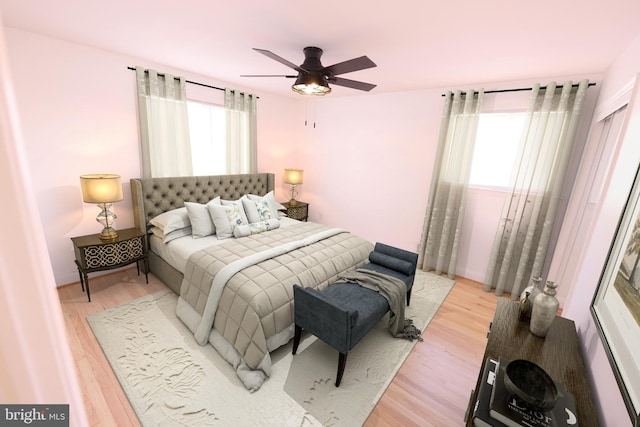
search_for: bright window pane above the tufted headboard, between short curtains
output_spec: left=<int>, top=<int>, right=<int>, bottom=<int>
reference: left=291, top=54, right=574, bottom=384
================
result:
left=187, top=101, right=227, bottom=176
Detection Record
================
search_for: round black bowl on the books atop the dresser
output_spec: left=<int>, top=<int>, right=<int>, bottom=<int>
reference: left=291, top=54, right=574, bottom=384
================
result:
left=504, top=359, right=558, bottom=411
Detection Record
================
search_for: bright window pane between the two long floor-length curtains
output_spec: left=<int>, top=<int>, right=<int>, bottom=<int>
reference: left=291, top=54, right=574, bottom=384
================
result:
left=469, top=112, right=526, bottom=189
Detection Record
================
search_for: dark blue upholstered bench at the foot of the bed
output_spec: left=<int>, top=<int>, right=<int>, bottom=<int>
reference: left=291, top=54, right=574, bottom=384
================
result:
left=293, top=243, right=418, bottom=387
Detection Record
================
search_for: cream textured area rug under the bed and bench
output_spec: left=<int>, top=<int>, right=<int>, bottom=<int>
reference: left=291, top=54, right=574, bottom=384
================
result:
left=87, top=271, right=454, bottom=427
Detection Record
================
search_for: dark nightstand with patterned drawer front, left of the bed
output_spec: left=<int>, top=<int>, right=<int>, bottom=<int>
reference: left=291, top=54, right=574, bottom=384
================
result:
left=71, top=228, right=149, bottom=302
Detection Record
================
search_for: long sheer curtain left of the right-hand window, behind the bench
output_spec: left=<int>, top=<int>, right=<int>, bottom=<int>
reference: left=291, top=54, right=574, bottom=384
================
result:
left=418, top=90, right=484, bottom=278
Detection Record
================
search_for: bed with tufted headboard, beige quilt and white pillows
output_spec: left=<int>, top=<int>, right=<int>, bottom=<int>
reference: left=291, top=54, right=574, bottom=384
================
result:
left=131, top=173, right=373, bottom=391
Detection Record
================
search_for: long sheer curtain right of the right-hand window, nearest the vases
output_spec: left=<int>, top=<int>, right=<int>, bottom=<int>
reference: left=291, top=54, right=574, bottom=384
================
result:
left=483, top=80, right=589, bottom=299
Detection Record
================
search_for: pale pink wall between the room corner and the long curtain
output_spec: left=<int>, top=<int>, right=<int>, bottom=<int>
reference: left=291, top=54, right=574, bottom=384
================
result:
left=296, top=91, right=441, bottom=251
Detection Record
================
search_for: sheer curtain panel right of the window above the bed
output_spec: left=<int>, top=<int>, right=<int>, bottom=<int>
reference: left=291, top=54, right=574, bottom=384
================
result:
left=224, top=89, right=258, bottom=173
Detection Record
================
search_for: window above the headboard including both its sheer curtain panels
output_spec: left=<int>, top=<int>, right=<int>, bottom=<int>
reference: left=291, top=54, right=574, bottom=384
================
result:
left=136, top=67, right=257, bottom=177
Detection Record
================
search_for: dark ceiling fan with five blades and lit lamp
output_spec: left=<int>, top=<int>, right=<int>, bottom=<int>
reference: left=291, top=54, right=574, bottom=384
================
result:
left=242, top=46, right=376, bottom=95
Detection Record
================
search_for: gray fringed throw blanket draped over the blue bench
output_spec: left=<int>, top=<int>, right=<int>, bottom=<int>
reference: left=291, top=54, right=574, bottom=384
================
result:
left=338, top=268, right=422, bottom=341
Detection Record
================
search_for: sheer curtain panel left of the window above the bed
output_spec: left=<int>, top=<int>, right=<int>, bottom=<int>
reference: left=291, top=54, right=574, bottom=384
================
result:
left=136, top=67, right=193, bottom=178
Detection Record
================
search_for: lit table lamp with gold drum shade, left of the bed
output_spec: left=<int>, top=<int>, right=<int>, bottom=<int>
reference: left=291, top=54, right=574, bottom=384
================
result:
left=80, top=174, right=123, bottom=240
